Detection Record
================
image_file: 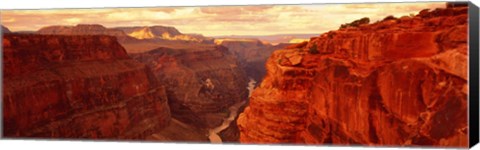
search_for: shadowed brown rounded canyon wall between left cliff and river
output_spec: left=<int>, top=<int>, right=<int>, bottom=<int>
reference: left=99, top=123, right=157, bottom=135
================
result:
left=132, top=45, right=248, bottom=128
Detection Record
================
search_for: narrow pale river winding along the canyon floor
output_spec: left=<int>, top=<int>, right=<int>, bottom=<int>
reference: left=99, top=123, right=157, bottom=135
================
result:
left=208, top=78, right=256, bottom=143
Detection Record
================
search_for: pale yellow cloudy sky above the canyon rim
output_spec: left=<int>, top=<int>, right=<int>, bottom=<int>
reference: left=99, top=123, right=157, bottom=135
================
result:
left=0, top=2, right=445, bottom=36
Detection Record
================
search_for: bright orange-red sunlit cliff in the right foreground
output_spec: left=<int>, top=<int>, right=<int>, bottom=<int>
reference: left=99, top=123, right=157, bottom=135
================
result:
left=237, top=4, right=468, bottom=147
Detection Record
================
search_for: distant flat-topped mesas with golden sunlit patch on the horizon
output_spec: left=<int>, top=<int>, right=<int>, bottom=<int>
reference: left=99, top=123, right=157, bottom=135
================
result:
left=36, top=24, right=213, bottom=53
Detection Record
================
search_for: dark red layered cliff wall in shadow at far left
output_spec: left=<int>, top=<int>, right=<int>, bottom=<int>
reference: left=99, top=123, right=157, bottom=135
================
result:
left=3, top=34, right=171, bottom=140
